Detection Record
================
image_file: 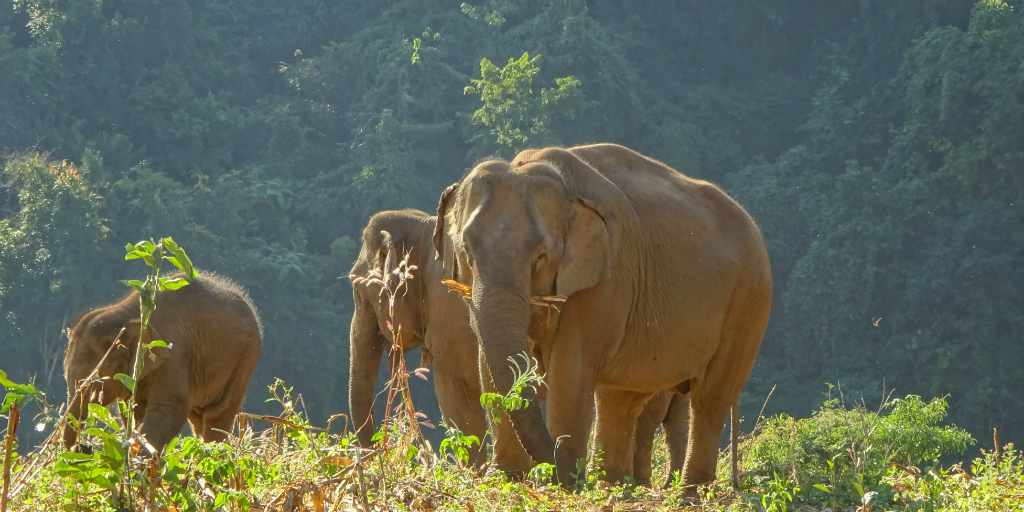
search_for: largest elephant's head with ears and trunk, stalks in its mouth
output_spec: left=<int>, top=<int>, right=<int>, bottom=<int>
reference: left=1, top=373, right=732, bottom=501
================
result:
left=433, top=148, right=612, bottom=463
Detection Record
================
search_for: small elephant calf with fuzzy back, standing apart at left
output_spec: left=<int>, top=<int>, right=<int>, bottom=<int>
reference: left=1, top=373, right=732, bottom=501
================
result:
left=63, top=271, right=263, bottom=452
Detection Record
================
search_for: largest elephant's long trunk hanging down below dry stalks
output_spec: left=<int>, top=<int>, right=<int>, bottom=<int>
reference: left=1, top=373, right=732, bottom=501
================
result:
left=471, top=279, right=555, bottom=464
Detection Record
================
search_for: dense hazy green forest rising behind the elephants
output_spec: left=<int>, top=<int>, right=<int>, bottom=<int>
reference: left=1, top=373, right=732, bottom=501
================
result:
left=0, top=0, right=1024, bottom=446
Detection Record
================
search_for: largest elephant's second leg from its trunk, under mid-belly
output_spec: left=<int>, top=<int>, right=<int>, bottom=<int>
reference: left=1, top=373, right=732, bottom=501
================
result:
left=595, top=387, right=656, bottom=481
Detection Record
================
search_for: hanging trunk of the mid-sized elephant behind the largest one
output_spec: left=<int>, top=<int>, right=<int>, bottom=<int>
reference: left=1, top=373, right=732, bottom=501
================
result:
left=348, top=294, right=386, bottom=447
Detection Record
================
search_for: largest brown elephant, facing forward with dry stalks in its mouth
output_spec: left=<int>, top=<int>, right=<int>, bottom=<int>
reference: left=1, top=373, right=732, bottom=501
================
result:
left=433, top=144, right=771, bottom=485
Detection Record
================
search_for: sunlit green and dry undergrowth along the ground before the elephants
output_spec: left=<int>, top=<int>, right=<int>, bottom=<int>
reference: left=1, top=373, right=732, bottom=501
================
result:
left=4, top=372, right=1024, bottom=511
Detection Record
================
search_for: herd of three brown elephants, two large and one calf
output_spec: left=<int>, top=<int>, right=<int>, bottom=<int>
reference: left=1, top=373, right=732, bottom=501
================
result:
left=65, top=144, right=771, bottom=487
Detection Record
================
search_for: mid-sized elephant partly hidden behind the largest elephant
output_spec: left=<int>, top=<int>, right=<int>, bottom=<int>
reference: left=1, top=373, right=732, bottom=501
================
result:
left=348, top=210, right=532, bottom=473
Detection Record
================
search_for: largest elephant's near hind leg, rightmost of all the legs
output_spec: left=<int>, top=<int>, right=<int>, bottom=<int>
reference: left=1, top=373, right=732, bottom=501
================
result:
left=683, top=291, right=771, bottom=484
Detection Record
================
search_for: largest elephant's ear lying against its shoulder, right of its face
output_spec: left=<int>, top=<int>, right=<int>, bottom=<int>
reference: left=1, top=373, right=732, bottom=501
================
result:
left=555, top=198, right=611, bottom=297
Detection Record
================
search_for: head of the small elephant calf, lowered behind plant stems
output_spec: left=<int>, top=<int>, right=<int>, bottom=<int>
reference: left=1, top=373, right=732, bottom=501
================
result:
left=63, top=308, right=170, bottom=449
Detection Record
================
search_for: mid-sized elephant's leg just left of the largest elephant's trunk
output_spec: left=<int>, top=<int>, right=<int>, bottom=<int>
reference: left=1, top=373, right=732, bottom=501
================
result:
left=433, top=352, right=487, bottom=466
